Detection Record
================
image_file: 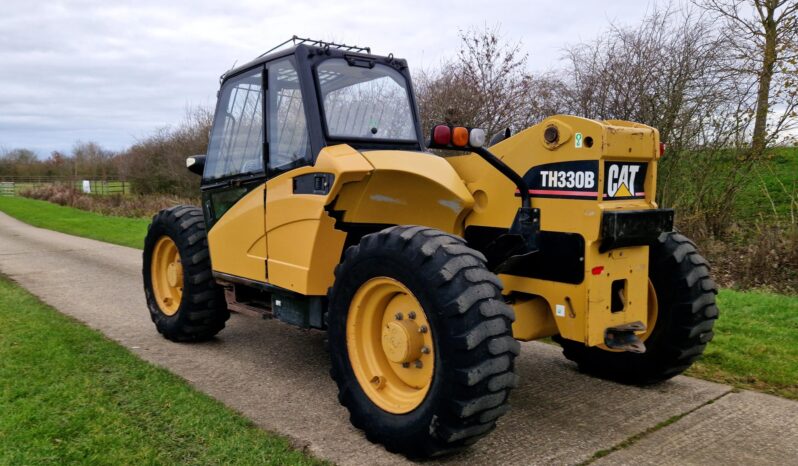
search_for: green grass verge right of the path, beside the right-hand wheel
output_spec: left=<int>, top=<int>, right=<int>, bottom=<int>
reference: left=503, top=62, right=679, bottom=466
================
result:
left=687, top=290, right=798, bottom=400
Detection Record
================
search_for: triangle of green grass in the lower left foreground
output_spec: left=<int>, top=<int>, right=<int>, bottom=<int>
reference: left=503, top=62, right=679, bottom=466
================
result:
left=0, top=277, right=319, bottom=465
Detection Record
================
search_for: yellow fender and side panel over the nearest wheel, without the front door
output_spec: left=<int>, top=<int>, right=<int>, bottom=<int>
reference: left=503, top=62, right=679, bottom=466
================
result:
left=266, top=145, right=473, bottom=295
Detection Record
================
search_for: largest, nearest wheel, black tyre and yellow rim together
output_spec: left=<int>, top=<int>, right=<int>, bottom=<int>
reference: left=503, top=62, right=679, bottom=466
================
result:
left=329, top=226, right=520, bottom=457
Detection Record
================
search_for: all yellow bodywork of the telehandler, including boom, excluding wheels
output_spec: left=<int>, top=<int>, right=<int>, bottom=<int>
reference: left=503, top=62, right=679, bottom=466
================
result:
left=208, top=116, right=659, bottom=346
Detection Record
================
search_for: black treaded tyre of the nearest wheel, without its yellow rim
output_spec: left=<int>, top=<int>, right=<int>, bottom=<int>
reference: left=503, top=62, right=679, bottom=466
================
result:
left=329, top=226, right=520, bottom=458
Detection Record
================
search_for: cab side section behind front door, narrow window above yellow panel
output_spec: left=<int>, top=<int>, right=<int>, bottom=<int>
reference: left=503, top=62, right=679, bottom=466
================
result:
left=266, top=56, right=344, bottom=295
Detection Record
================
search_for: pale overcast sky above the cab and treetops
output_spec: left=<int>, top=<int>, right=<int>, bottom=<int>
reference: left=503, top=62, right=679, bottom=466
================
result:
left=0, top=0, right=654, bottom=157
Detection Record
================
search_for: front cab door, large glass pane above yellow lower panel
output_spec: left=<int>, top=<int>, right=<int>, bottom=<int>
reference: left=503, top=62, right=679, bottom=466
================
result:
left=202, top=66, right=267, bottom=282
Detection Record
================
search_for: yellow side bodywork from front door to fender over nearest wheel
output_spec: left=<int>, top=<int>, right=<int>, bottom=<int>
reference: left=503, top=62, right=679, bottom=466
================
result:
left=208, top=145, right=474, bottom=296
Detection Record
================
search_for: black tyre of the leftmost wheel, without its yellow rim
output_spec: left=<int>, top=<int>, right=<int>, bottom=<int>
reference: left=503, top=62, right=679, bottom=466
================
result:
left=142, top=206, right=230, bottom=342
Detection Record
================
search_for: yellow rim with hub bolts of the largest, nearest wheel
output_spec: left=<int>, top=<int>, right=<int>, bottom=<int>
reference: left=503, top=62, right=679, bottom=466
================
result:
left=346, top=277, right=435, bottom=414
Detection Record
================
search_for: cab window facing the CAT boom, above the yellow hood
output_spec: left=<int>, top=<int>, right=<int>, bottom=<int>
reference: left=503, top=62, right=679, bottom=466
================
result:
left=316, top=58, right=418, bottom=141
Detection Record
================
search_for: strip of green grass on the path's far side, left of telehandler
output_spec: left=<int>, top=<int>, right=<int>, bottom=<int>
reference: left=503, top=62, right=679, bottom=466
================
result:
left=0, top=197, right=150, bottom=249
